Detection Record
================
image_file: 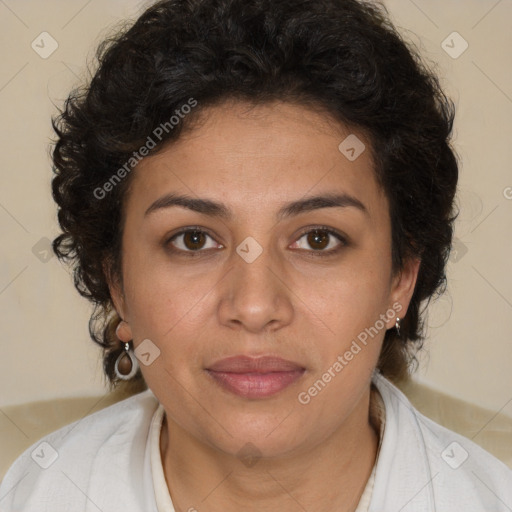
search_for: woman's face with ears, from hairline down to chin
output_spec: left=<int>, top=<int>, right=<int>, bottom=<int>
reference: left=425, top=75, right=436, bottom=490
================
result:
left=111, top=98, right=418, bottom=455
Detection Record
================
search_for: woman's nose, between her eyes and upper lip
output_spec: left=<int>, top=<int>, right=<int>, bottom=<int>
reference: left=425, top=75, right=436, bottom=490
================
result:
left=218, top=245, right=293, bottom=333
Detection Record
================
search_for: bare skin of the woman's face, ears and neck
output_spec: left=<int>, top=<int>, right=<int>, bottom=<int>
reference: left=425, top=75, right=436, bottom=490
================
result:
left=110, top=102, right=419, bottom=512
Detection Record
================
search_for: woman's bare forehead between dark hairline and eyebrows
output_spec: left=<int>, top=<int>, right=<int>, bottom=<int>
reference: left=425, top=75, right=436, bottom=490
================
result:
left=129, top=102, right=386, bottom=220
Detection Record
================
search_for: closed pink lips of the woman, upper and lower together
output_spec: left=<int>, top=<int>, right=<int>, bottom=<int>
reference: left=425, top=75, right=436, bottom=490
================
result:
left=206, top=356, right=306, bottom=399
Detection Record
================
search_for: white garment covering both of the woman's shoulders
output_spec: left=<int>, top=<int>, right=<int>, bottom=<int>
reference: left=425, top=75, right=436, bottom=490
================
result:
left=0, top=374, right=512, bottom=512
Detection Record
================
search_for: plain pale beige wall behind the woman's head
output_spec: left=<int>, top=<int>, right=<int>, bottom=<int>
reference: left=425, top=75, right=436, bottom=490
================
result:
left=0, top=0, right=512, bottom=417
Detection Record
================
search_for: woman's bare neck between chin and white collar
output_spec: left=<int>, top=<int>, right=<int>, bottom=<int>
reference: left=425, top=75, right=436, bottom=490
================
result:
left=160, top=390, right=379, bottom=512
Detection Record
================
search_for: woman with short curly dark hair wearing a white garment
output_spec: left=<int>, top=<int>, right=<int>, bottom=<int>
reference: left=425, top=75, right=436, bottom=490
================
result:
left=0, top=0, right=512, bottom=512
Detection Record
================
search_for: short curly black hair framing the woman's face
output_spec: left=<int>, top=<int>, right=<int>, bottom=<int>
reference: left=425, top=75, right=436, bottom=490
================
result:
left=52, top=0, right=458, bottom=389
